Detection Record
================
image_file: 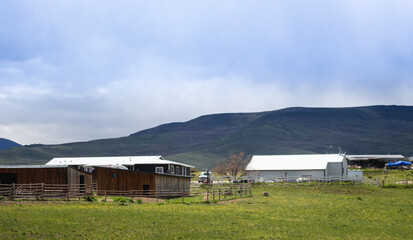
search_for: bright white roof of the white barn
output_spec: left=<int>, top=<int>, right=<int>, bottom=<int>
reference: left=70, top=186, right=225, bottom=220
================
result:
left=245, top=154, right=344, bottom=171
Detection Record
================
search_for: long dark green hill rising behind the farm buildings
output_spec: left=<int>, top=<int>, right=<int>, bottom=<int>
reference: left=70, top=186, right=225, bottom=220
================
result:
left=0, top=106, right=413, bottom=168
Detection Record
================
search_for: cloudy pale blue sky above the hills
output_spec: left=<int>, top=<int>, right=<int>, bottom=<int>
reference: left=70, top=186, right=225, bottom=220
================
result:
left=0, top=0, right=413, bottom=144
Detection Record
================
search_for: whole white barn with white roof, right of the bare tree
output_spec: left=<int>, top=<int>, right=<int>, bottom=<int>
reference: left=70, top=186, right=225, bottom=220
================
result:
left=245, top=154, right=348, bottom=181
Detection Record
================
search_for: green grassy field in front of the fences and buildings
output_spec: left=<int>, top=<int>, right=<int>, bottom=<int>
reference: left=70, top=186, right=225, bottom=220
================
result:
left=0, top=184, right=413, bottom=239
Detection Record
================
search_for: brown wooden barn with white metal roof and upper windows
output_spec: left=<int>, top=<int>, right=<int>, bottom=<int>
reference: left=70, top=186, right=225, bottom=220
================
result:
left=46, top=156, right=194, bottom=196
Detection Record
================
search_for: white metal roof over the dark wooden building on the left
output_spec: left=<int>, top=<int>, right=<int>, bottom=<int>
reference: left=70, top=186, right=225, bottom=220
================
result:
left=46, top=156, right=195, bottom=168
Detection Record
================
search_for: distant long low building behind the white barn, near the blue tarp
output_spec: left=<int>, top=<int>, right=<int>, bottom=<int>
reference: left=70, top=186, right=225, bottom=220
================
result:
left=346, top=154, right=405, bottom=168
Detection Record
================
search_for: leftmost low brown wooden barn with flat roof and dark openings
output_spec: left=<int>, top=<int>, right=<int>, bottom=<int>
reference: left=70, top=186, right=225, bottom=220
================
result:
left=0, top=165, right=92, bottom=186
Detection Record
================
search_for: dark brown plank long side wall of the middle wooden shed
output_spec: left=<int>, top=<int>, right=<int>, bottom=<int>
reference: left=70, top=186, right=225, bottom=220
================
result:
left=93, top=168, right=155, bottom=191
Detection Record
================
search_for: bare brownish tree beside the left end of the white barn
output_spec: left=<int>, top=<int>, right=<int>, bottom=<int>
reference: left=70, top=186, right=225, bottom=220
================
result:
left=213, top=152, right=251, bottom=177
